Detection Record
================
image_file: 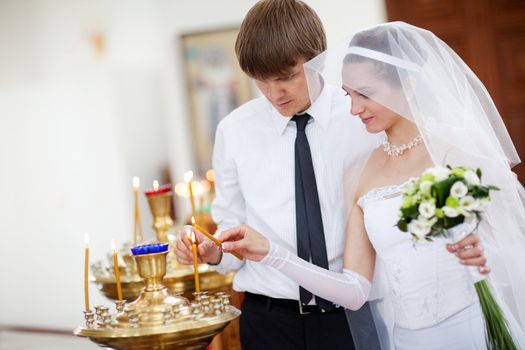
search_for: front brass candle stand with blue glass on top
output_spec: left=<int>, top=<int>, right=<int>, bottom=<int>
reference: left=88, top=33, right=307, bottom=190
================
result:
left=74, top=246, right=240, bottom=349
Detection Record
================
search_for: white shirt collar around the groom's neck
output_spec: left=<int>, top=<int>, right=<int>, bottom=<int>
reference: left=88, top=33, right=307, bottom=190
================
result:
left=268, top=85, right=331, bottom=135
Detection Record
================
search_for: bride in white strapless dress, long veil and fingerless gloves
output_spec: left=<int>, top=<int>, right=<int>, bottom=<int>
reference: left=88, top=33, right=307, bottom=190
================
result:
left=219, top=22, right=525, bottom=349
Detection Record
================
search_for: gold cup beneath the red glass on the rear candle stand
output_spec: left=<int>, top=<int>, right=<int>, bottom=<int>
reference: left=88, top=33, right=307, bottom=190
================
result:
left=147, top=191, right=173, bottom=242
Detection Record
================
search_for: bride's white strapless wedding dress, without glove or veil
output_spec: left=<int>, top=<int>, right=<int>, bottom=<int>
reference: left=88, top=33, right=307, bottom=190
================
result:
left=358, top=184, right=486, bottom=350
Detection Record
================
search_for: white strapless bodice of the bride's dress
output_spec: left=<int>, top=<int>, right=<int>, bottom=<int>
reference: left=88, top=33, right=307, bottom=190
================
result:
left=357, top=181, right=475, bottom=329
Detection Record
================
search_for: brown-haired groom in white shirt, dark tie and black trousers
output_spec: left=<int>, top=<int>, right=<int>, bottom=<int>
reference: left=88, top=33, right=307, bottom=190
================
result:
left=176, top=0, right=379, bottom=350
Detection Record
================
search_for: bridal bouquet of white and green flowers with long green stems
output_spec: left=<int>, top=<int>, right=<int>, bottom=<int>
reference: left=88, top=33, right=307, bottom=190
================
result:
left=397, top=166, right=517, bottom=349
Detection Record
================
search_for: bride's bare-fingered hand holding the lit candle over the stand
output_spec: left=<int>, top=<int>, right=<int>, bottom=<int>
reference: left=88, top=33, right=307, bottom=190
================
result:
left=218, top=225, right=270, bottom=261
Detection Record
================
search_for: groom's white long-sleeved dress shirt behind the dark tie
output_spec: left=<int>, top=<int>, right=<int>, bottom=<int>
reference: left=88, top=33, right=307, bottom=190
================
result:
left=212, top=86, right=372, bottom=300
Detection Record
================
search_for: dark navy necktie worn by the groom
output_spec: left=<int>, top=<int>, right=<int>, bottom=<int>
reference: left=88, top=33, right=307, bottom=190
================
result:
left=292, top=114, right=333, bottom=309
